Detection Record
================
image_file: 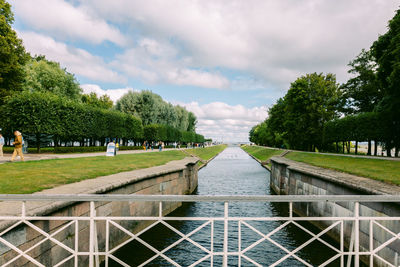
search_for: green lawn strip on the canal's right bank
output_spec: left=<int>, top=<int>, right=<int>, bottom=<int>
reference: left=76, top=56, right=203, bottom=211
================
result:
left=285, top=152, right=400, bottom=185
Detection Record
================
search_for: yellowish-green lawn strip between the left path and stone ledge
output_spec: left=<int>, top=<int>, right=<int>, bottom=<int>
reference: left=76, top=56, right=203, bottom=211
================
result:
left=0, top=151, right=187, bottom=194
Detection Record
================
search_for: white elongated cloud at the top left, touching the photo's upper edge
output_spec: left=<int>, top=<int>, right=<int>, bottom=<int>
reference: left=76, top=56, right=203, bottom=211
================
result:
left=13, top=0, right=127, bottom=46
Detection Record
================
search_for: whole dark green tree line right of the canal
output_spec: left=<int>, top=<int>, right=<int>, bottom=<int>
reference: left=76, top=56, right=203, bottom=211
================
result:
left=249, top=7, right=400, bottom=156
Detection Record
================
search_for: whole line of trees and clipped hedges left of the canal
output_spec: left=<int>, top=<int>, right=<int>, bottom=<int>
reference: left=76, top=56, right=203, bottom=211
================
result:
left=0, top=0, right=204, bottom=153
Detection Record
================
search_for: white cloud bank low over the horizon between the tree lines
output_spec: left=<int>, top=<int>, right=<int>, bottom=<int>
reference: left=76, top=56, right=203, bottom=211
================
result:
left=176, top=102, right=268, bottom=142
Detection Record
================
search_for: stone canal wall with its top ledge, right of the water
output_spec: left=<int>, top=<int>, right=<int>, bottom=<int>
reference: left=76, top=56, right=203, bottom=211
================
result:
left=270, top=157, right=400, bottom=266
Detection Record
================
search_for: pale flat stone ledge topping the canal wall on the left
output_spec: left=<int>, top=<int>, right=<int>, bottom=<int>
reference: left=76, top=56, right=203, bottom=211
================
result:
left=0, top=157, right=198, bottom=229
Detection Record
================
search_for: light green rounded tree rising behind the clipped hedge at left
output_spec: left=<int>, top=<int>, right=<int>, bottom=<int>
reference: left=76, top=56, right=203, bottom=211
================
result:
left=24, top=56, right=82, bottom=100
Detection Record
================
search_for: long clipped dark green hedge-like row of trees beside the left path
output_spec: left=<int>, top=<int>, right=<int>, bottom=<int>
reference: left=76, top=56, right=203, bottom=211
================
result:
left=0, top=92, right=143, bottom=150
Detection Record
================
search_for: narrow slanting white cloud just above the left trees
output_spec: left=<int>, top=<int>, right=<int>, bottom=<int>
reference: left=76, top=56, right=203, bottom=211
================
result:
left=18, top=31, right=126, bottom=82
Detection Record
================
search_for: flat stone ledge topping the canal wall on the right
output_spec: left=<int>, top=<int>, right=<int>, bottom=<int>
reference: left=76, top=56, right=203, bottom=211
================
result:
left=271, top=157, right=400, bottom=195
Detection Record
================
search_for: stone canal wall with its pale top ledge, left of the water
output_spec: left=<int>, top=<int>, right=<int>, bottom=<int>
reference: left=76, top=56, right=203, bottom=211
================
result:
left=0, top=157, right=198, bottom=266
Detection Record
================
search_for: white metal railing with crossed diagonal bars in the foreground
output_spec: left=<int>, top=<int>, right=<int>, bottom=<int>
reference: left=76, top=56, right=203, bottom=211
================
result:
left=0, top=195, right=400, bottom=267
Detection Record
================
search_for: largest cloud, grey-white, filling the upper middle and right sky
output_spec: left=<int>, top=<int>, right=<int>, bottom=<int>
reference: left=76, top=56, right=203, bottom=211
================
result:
left=81, top=0, right=398, bottom=88
